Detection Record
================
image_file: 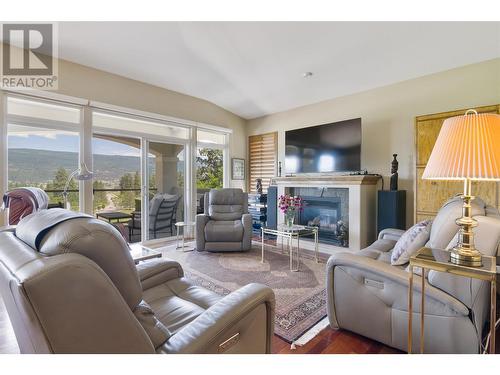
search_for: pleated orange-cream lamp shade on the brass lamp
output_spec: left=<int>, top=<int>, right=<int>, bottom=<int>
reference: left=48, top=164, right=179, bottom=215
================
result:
left=422, top=111, right=500, bottom=180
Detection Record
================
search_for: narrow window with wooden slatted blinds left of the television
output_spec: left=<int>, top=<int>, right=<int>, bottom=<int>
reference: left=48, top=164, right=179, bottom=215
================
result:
left=248, top=132, right=278, bottom=193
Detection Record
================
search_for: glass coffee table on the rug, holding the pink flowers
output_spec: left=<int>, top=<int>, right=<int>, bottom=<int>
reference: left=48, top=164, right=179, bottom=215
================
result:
left=261, top=224, right=319, bottom=272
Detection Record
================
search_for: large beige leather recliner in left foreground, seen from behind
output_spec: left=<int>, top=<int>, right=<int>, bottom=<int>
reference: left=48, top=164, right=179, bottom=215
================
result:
left=0, top=209, right=274, bottom=353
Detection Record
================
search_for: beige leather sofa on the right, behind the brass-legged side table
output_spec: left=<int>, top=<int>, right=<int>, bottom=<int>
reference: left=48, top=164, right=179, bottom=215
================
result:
left=327, top=198, right=500, bottom=353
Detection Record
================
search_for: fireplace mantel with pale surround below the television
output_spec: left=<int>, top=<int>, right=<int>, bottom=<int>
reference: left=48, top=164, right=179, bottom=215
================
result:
left=271, top=175, right=380, bottom=253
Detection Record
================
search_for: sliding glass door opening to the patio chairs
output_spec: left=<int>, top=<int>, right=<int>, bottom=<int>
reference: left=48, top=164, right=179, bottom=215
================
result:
left=92, top=112, right=188, bottom=242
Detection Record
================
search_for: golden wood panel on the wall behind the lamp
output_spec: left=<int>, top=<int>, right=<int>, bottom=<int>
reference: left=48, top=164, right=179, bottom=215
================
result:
left=414, top=104, right=500, bottom=222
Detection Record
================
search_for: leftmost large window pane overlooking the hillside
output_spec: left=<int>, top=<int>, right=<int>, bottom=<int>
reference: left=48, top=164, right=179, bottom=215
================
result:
left=7, top=97, right=80, bottom=210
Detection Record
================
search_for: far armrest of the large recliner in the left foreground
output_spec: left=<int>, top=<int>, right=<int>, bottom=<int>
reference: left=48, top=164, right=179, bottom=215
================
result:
left=136, top=259, right=184, bottom=290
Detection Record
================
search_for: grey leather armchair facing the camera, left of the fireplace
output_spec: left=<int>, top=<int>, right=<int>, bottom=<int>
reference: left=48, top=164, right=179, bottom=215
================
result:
left=196, top=189, right=252, bottom=251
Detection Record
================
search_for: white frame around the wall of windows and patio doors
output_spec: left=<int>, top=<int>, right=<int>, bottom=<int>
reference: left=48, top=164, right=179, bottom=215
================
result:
left=0, top=90, right=233, bottom=231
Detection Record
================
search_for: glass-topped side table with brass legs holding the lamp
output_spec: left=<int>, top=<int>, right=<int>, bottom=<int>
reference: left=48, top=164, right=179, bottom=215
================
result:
left=408, top=247, right=497, bottom=354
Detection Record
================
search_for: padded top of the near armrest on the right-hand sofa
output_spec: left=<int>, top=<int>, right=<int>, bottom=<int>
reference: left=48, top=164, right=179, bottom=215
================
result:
left=327, top=253, right=469, bottom=320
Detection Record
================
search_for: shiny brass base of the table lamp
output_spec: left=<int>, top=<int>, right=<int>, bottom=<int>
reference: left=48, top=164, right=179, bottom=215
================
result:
left=450, top=179, right=482, bottom=267
